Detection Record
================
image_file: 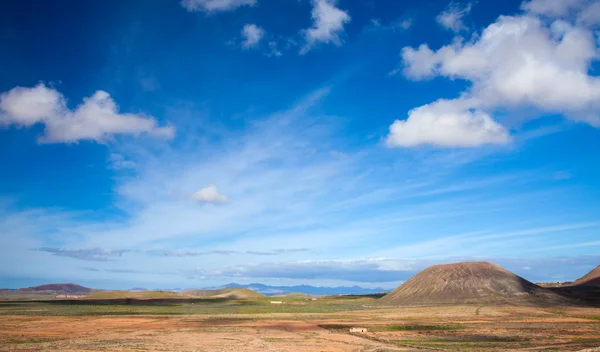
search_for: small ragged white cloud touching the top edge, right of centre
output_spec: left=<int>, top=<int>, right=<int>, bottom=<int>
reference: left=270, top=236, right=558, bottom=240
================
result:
left=300, top=0, right=350, bottom=54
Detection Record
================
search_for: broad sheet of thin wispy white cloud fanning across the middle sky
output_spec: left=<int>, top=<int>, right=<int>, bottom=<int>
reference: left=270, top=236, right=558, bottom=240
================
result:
left=0, top=87, right=596, bottom=286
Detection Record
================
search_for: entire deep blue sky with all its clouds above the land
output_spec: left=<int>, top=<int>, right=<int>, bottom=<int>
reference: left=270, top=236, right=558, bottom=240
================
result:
left=0, top=0, right=600, bottom=288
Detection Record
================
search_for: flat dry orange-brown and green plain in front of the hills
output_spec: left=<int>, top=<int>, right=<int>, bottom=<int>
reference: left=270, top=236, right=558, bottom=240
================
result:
left=0, top=297, right=600, bottom=352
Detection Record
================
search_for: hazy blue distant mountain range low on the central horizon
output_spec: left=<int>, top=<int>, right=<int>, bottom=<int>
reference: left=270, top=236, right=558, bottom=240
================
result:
left=213, top=282, right=389, bottom=296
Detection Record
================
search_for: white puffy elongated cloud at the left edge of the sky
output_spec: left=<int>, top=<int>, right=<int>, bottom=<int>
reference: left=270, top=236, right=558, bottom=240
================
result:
left=0, top=83, right=175, bottom=143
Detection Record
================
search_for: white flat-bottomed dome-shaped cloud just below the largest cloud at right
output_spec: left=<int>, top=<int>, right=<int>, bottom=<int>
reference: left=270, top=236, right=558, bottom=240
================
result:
left=386, top=100, right=510, bottom=147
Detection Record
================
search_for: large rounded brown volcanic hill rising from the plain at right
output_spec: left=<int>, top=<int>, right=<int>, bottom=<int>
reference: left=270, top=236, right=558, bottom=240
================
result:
left=382, top=262, right=560, bottom=305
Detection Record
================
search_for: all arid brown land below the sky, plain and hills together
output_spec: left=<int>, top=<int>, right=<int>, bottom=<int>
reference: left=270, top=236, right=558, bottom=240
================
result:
left=0, top=262, right=600, bottom=352
